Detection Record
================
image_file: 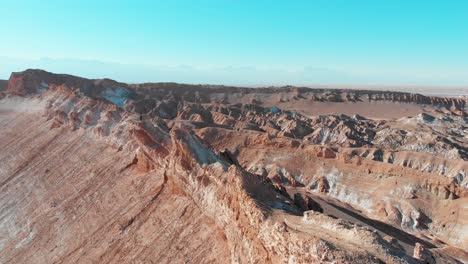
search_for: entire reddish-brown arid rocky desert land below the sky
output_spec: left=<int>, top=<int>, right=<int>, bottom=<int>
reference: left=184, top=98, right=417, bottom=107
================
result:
left=0, top=70, right=468, bottom=263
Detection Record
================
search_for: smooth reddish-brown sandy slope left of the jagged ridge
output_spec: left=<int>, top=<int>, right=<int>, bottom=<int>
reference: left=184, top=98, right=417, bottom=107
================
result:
left=0, top=106, right=230, bottom=263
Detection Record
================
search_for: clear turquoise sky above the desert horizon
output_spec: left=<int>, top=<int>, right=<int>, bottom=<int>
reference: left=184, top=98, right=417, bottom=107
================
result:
left=0, top=0, right=468, bottom=86
